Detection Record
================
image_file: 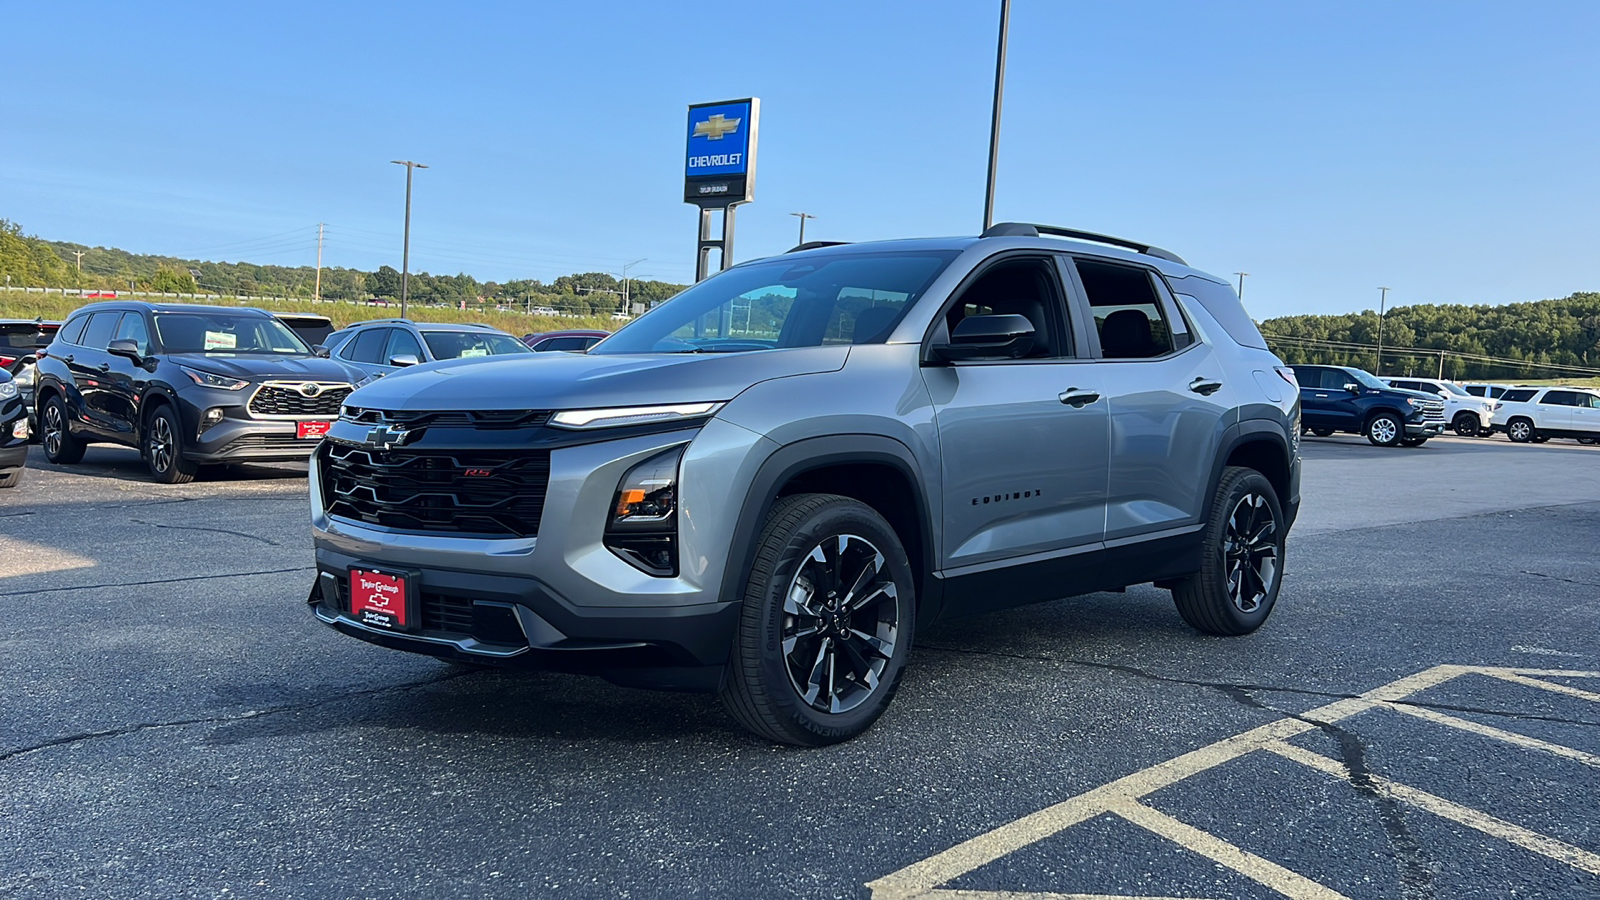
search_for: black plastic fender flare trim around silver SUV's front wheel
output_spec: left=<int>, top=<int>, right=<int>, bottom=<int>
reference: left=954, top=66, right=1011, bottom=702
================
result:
left=720, top=434, right=938, bottom=611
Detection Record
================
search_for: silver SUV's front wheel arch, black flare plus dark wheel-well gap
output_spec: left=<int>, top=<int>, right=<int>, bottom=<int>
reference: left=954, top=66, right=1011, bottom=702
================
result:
left=722, top=434, right=936, bottom=621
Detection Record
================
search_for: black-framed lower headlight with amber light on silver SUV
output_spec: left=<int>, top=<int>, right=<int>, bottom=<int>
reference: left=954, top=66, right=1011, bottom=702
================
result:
left=605, top=444, right=688, bottom=578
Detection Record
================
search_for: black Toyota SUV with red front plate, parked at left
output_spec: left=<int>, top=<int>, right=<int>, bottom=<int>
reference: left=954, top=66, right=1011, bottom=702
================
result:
left=37, top=301, right=363, bottom=484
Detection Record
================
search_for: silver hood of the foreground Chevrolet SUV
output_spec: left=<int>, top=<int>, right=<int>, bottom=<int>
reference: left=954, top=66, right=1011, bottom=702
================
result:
left=346, top=346, right=850, bottom=410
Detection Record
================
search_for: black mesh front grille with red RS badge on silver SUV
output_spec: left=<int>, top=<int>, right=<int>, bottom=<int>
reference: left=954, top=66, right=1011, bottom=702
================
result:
left=317, top=442, right=550, bottom=538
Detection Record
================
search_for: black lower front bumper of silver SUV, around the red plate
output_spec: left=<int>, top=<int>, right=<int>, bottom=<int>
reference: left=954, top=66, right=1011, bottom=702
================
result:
left=309, top=548, right=741, bottom=690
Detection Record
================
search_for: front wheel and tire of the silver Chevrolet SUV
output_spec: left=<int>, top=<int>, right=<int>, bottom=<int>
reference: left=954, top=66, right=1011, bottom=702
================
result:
left=718, top=493, right=917, bottom=746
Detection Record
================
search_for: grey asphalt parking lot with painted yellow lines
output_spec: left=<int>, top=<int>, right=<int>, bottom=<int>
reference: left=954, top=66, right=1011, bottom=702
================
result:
left=0, top=437, right=1600, bottom=900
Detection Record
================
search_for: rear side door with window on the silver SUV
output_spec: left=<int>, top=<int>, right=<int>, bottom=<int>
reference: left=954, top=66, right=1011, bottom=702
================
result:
left=1067, top=256, right=1245, bottom=551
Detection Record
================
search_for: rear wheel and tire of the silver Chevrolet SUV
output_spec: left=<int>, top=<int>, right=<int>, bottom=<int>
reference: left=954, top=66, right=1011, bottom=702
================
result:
left=1173, top=466, right=1288, bottom=636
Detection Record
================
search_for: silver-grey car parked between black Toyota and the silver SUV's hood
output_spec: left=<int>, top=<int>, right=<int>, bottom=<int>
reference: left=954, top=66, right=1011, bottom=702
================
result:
left=323, top=319, right=531, bottom=376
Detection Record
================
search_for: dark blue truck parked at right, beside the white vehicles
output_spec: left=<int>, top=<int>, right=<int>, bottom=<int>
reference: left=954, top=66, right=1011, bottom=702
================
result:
left=1294, top=365, right=1445, bottom=447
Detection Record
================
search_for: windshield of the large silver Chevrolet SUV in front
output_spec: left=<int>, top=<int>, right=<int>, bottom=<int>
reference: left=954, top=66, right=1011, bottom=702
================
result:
left=589, top=251, right=957, bottom=354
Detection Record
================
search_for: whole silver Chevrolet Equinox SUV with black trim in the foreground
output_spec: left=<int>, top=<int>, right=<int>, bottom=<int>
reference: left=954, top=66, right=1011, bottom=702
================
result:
left=310, top=223, right=1301, bottom=745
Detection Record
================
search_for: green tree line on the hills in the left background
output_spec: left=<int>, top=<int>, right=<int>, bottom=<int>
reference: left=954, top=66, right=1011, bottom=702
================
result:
left=0, top=219, right=683, bottom=315
